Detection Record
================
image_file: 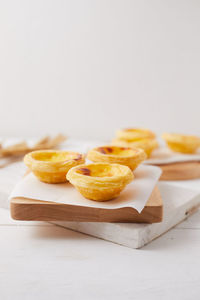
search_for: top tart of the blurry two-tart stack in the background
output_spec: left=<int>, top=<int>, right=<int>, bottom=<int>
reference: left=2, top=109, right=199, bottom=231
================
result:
left=116, top=128, right=155, bottom=142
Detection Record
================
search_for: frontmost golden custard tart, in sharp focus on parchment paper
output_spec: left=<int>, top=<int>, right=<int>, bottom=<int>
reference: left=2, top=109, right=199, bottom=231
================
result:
left=67, top=163, right=134, bottom=201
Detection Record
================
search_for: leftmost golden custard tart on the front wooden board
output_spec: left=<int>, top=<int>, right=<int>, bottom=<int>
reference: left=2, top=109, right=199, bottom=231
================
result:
left=24, top=150, right=85, bottom=183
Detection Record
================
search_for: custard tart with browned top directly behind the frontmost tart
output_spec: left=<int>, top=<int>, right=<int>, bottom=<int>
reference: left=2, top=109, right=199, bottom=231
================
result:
left=87, top=146, right=147, bottom=171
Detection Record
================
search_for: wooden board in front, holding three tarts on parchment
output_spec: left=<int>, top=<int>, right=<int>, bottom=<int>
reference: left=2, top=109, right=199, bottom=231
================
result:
left=10, top=187, right=163, bottom=223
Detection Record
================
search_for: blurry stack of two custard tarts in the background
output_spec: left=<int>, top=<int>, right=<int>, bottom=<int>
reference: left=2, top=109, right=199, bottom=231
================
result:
left=111, top=128, right=158, bottom=158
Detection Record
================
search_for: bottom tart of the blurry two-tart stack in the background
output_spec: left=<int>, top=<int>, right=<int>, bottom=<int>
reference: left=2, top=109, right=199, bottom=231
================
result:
left=111, top=139, right=158, bottom=158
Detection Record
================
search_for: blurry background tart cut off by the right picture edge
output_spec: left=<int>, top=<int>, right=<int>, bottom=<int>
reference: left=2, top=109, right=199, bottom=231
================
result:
left=162, top=133, right=200, bottom=154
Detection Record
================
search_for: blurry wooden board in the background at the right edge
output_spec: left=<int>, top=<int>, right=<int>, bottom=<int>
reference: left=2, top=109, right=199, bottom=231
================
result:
left=157, top=161, right=200, bottom=180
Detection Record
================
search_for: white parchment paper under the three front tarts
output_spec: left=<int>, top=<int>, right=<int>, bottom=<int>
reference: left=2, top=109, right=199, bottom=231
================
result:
left=10, top=165, right=161, bottom=213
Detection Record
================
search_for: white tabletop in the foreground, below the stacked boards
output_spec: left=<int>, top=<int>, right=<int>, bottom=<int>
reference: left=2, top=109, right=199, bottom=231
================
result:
left=0, top=209, right=200, bottom=300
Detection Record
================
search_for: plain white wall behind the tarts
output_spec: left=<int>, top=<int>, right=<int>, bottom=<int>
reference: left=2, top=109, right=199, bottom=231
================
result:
left=0, top=0, right=200, bottom=139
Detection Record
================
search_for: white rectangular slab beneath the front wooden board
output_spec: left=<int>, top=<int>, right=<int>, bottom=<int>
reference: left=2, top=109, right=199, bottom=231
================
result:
left=53, top=182, right=200, bottom=248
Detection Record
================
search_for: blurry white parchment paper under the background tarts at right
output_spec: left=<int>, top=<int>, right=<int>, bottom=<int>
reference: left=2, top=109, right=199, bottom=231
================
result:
left=144, top=147, right=200, bottom=165
